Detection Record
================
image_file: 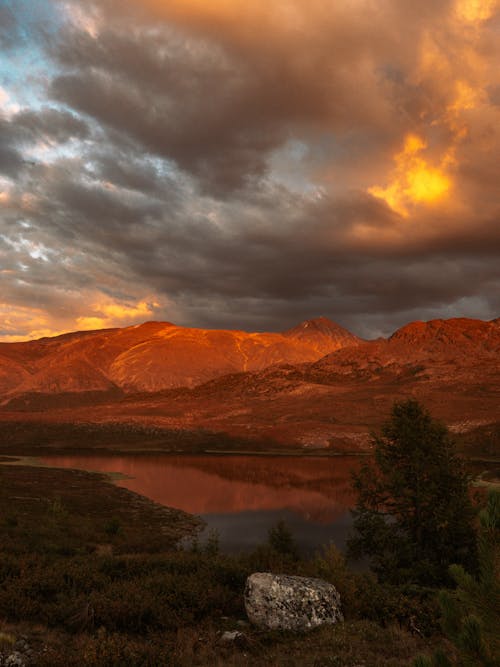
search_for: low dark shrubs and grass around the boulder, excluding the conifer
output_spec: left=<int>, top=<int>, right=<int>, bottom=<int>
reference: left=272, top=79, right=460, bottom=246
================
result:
left=0, top=466, right=446, bottom=667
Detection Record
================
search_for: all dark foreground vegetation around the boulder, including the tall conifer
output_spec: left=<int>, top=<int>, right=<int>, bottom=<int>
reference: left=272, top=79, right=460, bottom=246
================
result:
left=0, top=401, right=500, bottom=667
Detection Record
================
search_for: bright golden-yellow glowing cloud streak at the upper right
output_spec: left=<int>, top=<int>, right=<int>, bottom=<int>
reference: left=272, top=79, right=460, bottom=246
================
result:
left=368, top=0, right=494, bottom=217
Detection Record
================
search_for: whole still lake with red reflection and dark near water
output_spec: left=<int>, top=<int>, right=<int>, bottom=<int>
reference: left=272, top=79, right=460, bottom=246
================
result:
left=42, top=455, right=362, bottom=552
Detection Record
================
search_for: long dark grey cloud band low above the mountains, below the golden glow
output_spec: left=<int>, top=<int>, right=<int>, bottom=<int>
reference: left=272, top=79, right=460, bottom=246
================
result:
left=12, top=157, right=496, bottom=329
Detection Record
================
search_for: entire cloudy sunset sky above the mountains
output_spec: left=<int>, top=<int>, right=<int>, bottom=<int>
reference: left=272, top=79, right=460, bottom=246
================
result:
left=0, top=0, right=500, bottom=342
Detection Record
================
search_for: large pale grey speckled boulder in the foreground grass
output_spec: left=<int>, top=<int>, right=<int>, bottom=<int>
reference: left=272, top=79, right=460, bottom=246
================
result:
left=245, top=572, right=343, bottom=631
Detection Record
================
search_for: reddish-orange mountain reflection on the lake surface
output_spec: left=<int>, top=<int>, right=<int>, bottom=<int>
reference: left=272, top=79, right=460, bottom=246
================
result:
left=39, top=455, right=360, bottom=524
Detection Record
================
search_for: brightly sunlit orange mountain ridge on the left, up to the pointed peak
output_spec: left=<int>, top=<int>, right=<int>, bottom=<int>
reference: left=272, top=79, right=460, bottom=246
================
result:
left=0, top=318, right=360, bottom=401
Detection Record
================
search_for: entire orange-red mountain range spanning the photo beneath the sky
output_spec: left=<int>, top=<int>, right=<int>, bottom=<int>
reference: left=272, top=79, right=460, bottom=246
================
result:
left=0, top=318, right=500, bottom=449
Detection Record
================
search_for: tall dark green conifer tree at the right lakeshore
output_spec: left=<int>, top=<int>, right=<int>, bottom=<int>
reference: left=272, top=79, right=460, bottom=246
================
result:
left=349, top=400, right=476, bottom=585
